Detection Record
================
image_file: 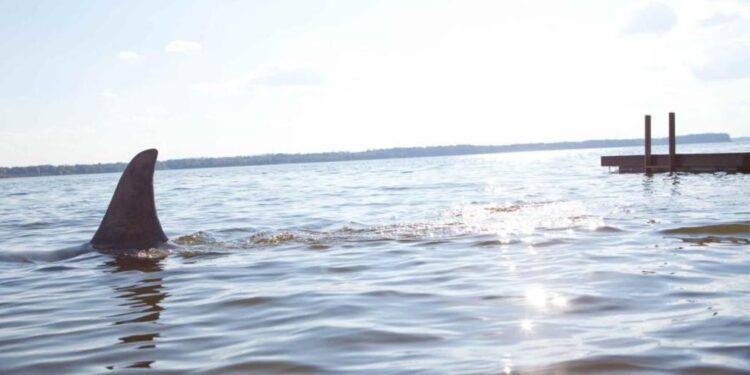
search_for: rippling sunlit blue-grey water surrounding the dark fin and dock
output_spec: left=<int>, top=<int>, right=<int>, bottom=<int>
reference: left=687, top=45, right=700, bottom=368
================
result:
left=0, top=143, right=750, bottom=374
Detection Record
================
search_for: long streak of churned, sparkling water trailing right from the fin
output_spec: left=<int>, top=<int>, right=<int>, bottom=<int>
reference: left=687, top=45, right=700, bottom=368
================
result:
left=163, top=202, right=622, bottom=253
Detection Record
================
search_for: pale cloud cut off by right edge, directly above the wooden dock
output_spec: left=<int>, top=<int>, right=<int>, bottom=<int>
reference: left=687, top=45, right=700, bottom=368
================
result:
left=693, top=41, right=750, bottom=81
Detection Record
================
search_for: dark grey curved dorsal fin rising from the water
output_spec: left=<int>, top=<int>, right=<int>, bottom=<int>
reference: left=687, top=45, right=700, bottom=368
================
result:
left=91, top=149, right=167, bottom=250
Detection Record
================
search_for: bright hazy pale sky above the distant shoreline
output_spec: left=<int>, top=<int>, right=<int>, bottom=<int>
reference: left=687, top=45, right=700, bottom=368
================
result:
left=0, top=0, right=750, bottom=166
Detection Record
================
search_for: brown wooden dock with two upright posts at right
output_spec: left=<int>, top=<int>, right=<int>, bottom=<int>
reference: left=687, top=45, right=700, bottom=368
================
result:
left=602, top=112, right=750, bottom=173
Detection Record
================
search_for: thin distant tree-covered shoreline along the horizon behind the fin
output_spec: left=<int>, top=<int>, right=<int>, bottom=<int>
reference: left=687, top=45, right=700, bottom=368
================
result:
left=0, top=133, right=736, bottom=178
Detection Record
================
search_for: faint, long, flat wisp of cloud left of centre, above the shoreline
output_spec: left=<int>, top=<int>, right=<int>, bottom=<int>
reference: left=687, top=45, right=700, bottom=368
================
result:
left=193, top=68, right=324, bottom=95
